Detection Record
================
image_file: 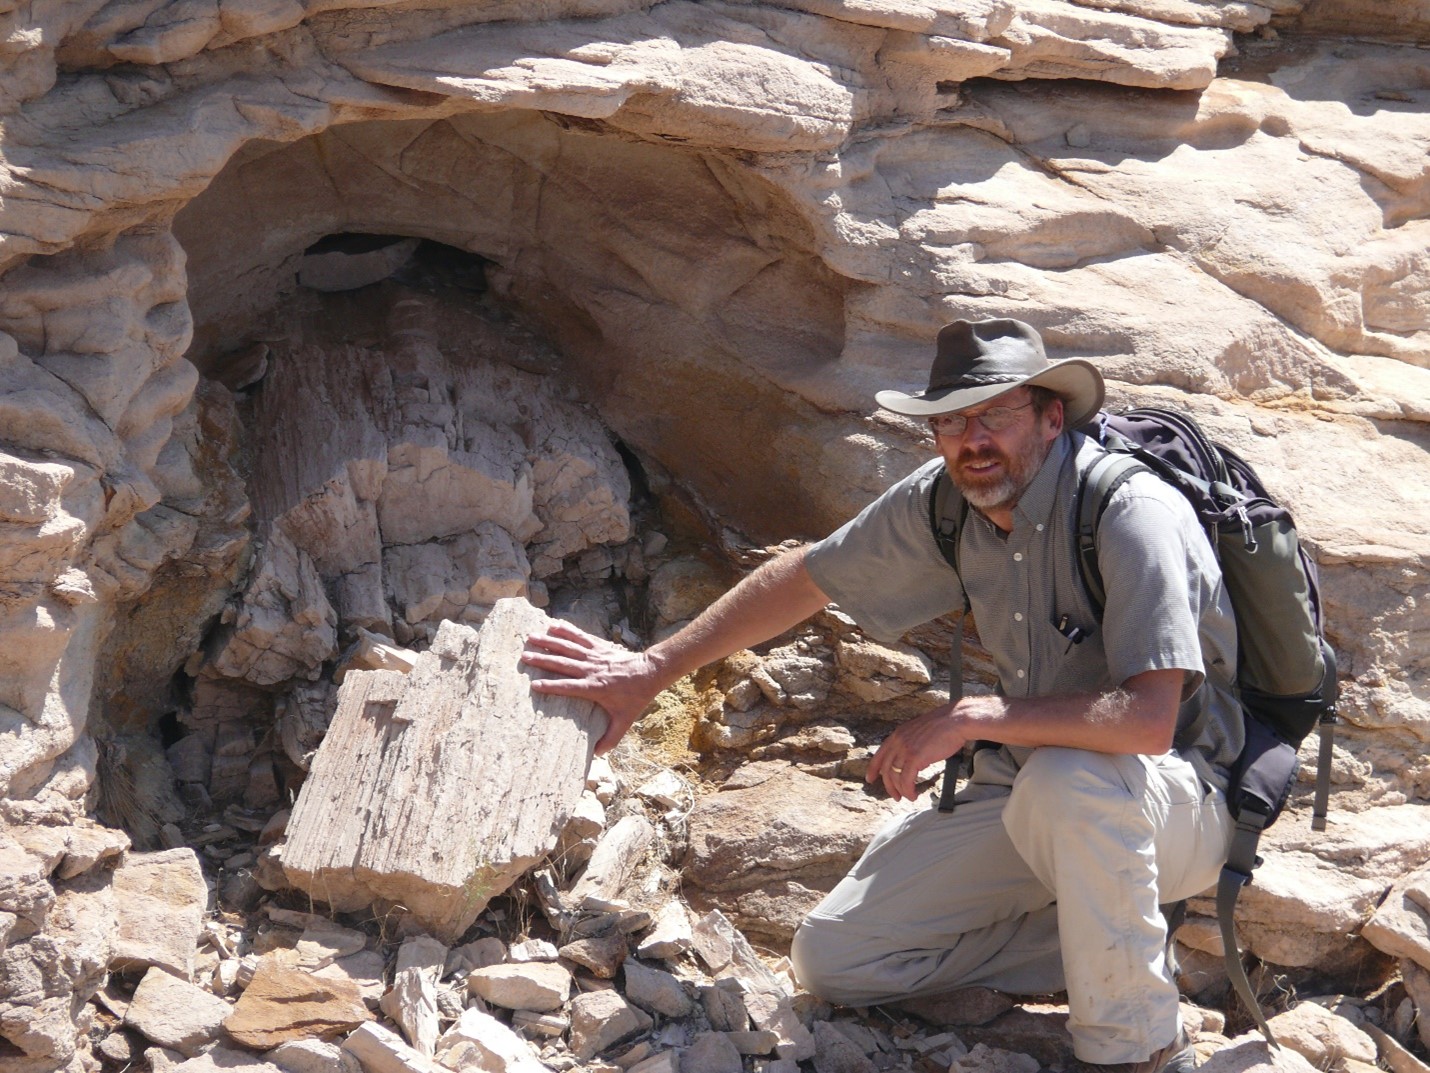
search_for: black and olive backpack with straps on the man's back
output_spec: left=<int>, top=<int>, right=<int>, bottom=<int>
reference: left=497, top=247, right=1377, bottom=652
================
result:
left=930, top=408, right=1337, bottom=1046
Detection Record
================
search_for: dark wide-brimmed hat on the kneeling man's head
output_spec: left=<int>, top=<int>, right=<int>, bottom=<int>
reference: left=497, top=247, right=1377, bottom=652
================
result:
left=874, top=320, right=1105, bottom=428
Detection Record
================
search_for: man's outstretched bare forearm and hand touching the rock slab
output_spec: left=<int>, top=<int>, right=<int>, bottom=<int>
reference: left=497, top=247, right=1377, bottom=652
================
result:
left=522, top=548, right=829, bottom=753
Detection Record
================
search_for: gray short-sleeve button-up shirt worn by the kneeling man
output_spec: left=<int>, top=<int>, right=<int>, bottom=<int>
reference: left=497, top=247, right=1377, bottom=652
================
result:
left=805, top=432, right=1243, bottom=788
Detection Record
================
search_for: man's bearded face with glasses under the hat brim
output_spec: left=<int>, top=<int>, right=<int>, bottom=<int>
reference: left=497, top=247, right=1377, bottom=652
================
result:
left=934, top=388, right=1062, bottom=511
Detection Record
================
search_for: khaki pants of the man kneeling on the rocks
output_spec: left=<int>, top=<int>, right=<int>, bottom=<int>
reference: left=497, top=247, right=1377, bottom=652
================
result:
left=791, top=748, right=1231, bottom=1063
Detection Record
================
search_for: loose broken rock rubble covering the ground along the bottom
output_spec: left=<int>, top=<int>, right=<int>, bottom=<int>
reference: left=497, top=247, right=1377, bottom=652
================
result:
left=44, top=680, right=1430, bottom=1073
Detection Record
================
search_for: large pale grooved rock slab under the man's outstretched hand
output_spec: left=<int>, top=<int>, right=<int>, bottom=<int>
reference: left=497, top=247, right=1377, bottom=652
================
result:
left=283, top=599, right=603, bottom=941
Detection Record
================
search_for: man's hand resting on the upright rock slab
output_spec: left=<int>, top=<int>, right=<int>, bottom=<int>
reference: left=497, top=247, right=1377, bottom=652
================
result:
left=522, top=622, right=666, bottom=753
